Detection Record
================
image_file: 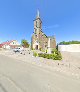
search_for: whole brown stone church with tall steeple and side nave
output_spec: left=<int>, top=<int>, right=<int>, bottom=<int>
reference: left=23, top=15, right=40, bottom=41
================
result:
left=31, top=11, right=56, bottom=50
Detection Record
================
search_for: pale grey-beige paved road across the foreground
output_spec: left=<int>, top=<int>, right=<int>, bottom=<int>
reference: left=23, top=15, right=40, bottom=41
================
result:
left=0, top=55, right=80, bottom=92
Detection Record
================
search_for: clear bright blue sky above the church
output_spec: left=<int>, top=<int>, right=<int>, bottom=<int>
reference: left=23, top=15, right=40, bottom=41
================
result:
left=0, top=0, right=80, bottom=43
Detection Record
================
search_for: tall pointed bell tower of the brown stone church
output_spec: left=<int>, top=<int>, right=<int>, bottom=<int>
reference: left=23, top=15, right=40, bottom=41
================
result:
left=32, top=10, right=42, bottom=49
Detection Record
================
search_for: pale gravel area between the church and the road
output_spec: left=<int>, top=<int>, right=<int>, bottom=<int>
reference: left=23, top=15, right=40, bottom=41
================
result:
left=0, top=49, right=80, bottom=78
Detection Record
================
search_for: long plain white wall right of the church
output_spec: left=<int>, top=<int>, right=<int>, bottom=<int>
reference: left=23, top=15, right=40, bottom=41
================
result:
left=58, top=44, right=80, bottom=52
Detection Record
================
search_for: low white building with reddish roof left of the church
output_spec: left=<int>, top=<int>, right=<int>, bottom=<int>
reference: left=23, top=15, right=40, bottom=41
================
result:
left=0, top=40, right=20, bottom=49
